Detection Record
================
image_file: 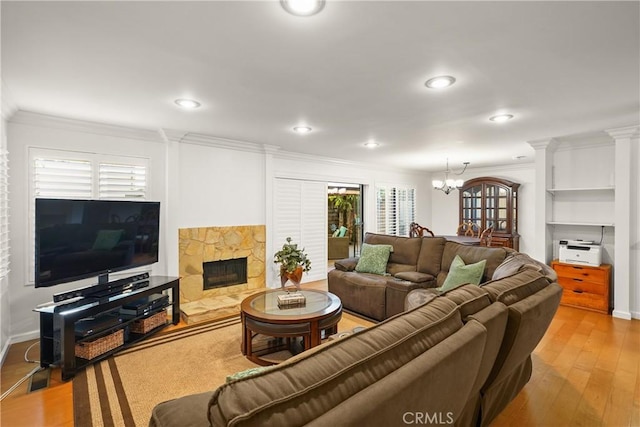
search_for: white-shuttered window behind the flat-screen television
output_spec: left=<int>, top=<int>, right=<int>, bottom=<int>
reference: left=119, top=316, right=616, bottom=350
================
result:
left=28, top=149, right=148, bottom=283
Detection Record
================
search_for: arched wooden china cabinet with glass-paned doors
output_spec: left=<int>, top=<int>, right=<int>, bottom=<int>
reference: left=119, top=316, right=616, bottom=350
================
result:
left=459, top=177, right=520, bottom=250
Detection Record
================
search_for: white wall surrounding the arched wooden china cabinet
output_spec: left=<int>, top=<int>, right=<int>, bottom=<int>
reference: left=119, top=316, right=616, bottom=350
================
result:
left=429, top=163, right=544, bottom=262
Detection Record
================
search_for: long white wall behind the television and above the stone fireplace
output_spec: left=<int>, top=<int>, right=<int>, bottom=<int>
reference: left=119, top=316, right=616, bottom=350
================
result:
left=2, top=112, right=431, bottom=342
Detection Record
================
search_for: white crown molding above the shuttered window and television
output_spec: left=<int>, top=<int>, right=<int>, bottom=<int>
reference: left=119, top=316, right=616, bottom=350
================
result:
left=10, top=110, right=164, bottom=142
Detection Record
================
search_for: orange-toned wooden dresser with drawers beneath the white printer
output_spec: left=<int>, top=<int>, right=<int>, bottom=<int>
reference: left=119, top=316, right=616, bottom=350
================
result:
left=551, top=260, right=611, bottom=314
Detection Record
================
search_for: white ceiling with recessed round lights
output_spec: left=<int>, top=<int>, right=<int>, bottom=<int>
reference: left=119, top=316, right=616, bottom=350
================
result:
left=1, top=0, right=640, bottom=170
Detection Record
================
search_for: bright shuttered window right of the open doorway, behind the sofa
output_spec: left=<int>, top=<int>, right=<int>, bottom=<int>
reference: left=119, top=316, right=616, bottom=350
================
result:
left=376, top=187, right=416, bottom=236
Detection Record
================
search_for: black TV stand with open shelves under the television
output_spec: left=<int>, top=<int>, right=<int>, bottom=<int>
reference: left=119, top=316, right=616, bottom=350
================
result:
left=34, top=276, right=180, bottom=381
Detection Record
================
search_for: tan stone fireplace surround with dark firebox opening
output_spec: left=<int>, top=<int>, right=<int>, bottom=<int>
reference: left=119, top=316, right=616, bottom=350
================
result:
left=178, top=225, right=266, bottom=313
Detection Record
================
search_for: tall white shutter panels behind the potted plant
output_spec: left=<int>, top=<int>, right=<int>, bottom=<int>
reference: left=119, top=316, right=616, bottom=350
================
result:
left=274, top=178, right=327, bottom=285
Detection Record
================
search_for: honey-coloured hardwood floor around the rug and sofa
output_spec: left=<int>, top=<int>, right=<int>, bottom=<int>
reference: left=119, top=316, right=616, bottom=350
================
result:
left=0, top=281, right=640, bottom=427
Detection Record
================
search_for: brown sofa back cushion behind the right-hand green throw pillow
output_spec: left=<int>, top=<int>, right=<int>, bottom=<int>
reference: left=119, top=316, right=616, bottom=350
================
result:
left=437, top=241, right=507, bottom=286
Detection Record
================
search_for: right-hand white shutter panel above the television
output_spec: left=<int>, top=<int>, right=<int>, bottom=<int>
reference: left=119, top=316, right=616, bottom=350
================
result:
left=98, top=163, right=147, bottom=199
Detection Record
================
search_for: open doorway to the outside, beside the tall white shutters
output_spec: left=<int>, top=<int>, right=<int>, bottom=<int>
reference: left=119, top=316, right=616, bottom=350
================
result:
left=327, top=182, right=363, bottom=260
